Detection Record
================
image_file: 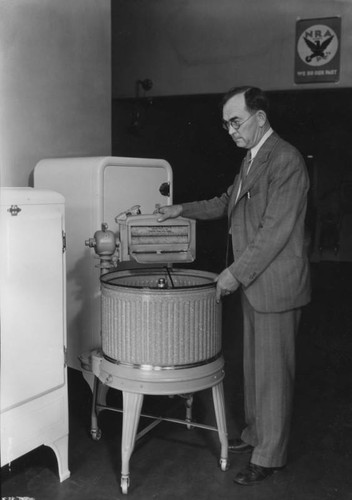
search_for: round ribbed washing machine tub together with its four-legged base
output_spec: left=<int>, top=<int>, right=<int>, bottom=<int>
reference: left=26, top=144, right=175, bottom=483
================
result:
left=91, top=268, right=228, bottom=493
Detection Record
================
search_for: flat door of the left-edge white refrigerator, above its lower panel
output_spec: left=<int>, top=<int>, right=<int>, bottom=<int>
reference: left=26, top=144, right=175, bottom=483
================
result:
left=0, top=189, right=65, bottom=411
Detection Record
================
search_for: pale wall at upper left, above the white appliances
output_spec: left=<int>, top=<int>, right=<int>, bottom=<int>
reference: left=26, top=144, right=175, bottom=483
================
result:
left=0, top=0, right=111, bottom=186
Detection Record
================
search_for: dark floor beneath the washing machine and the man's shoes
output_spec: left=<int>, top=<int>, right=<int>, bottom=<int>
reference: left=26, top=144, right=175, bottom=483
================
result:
left=2, top=262, right=352, bottom=500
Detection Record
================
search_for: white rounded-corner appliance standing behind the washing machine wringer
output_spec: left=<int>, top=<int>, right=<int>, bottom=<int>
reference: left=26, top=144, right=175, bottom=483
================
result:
left=34, top=157, right=172, bottom=370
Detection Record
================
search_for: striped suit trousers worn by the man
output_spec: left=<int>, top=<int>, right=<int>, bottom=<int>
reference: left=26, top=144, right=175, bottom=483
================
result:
left=241, top=292, right=301, bottom=467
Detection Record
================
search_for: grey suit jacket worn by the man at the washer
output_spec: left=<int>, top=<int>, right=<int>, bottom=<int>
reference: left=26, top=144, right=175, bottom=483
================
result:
left=182, top=133, right=310, bottom=312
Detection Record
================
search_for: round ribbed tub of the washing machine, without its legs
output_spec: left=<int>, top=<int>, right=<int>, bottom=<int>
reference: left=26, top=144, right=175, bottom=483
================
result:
left=101, top=268, right=221, bottom=368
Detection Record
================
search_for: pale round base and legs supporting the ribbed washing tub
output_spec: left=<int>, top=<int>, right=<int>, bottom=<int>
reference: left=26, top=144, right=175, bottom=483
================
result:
left=91, top=351, right=229, bottom=494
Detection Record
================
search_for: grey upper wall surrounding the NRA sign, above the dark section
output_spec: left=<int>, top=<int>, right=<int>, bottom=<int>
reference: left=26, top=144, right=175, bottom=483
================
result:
left=112, top=0, right=352, bottom=98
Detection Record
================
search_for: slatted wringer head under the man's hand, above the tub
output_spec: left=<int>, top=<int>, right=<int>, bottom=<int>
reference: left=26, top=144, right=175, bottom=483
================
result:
left=119, top=214, right=196, bottom=264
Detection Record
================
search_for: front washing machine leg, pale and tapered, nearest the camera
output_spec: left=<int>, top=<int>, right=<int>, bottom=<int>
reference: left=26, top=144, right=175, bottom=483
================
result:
left=121, top=391, right=143, bottom=494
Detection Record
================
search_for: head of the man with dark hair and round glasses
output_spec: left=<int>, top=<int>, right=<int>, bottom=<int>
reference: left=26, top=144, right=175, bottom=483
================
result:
left=222, top=87, right=270, bottom=149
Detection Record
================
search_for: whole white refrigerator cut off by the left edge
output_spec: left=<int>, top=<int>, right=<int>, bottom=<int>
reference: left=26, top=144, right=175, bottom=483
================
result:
left=0, top=188, right=70, bottom=481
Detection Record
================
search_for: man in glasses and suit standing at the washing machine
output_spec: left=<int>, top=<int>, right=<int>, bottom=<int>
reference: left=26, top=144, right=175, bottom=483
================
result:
left=159, top=87, right=310, bottom=485
